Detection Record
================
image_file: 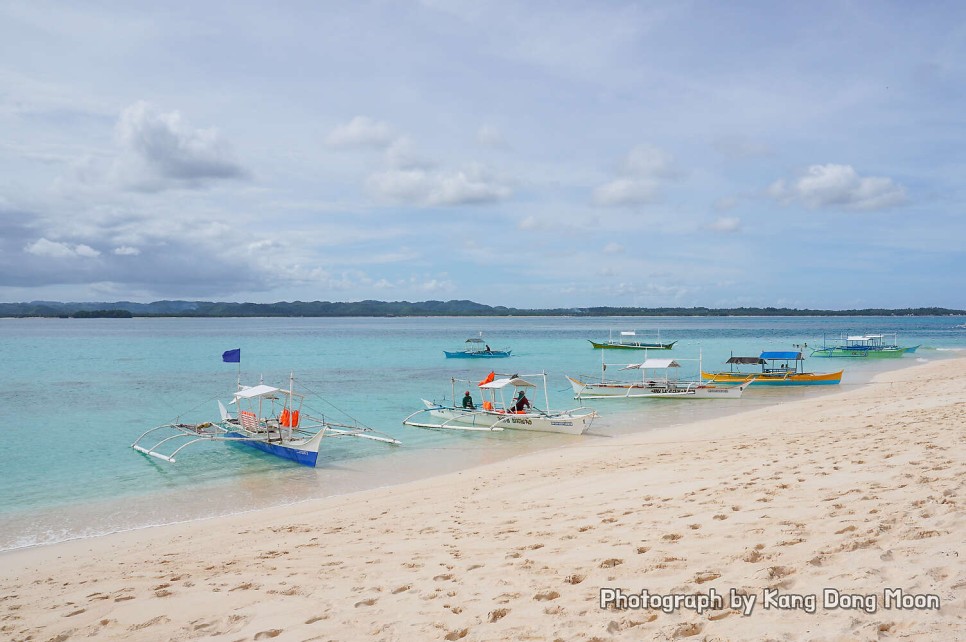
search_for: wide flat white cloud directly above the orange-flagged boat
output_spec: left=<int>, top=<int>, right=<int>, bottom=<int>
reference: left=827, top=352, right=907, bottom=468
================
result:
left=368, top=167, right=513, bottom=206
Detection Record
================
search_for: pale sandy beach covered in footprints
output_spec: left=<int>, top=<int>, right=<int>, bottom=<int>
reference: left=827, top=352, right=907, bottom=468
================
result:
left=0, top=359, right=966, bottom=641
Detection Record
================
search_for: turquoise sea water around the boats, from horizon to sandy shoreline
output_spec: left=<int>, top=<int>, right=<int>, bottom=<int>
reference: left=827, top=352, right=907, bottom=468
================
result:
left=0, top=317, right=966, bottom=550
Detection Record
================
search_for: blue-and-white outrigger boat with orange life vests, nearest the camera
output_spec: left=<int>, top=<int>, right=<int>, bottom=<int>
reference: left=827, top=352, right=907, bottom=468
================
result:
left=131, top=370, right=400, bottom=466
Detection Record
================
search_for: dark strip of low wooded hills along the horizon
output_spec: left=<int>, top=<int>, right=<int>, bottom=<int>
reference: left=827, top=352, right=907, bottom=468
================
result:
left=0, top=300, right=966, bottom=319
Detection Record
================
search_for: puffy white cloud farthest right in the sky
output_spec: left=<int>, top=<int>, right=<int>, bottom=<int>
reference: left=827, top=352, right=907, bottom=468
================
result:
left=768, top=163, right=906, bottom=210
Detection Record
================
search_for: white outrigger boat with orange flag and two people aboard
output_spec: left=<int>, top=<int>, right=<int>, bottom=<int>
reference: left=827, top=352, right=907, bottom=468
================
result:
left=403, top=372, right=597, bottom=435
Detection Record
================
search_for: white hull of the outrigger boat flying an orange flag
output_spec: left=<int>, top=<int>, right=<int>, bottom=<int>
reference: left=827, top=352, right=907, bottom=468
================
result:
left=424, top=406, right=597, bottom=435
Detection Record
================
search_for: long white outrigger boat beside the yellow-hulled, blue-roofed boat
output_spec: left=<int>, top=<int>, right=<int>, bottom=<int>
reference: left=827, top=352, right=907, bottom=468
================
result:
left=567, top=357, right=751, bottom=399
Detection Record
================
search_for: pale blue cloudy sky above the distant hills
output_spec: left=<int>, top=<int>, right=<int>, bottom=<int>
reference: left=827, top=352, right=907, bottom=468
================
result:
left=0, top=0, right=966, bottom=309
